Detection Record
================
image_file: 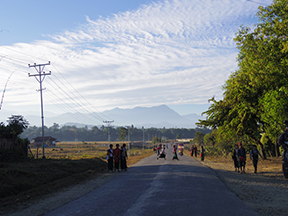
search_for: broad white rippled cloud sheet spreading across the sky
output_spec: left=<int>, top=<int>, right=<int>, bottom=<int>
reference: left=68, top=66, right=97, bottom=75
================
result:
left=0, top=0, right=271, bottom=115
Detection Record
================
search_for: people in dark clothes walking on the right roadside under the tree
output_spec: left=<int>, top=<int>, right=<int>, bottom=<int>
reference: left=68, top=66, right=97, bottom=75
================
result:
left=232, top=142, right=263, bottom=174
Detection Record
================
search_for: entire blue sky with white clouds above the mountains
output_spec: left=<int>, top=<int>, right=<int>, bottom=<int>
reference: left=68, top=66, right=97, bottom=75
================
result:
left=0, top=0, right=272, bottom=125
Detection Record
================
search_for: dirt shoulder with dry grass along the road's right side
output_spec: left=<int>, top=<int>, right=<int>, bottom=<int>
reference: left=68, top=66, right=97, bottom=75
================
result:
left=197, top=157, right=288, bottom=216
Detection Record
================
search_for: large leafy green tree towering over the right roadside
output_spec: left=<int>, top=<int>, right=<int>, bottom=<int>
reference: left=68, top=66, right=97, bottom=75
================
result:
left=198, top=0, right=288, bottom=158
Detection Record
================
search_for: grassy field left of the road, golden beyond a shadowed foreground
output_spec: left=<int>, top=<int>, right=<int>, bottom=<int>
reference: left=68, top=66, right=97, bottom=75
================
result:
left=0, top=142, right=152, bottom=214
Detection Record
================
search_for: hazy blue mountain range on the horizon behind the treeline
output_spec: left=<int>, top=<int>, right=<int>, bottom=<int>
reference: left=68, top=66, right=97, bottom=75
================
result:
left=0, top=105, right=205, bottom=128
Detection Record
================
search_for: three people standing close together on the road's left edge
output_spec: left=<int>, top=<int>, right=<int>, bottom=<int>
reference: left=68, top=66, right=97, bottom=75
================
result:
left=106, top=144, right=128, bottom=172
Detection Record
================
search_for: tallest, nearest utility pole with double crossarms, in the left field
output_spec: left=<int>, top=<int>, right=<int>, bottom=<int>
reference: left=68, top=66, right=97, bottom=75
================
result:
left=28, top=61, right=51, bottom=158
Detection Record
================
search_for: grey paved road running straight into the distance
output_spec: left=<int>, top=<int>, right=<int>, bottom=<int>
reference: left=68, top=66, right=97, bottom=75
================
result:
left=46, top=149, right=258, bottom=216
